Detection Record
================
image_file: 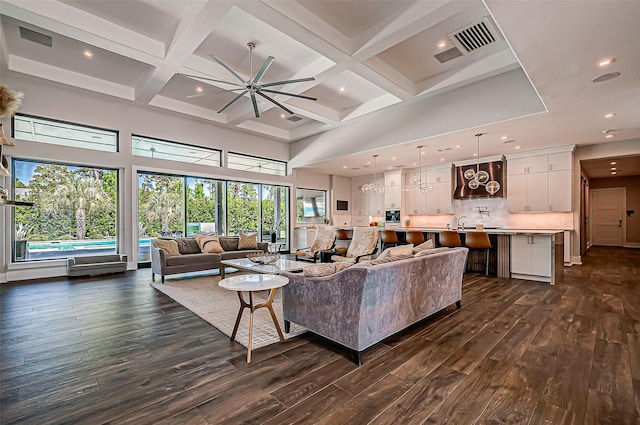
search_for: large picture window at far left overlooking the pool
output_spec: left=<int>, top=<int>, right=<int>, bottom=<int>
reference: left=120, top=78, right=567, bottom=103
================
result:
left=13, top=159, right=118, bottom=262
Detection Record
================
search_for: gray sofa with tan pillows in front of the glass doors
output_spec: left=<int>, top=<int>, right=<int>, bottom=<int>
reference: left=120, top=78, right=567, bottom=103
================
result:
left=151, top=236, right=268, bottom=283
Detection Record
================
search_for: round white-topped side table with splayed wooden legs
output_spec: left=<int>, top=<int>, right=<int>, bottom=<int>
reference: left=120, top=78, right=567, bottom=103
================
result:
left=218, top=274, right=289, bottom=363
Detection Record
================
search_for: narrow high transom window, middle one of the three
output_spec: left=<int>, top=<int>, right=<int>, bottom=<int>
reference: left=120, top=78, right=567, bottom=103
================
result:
left=131, top=135, right=222, bottom=167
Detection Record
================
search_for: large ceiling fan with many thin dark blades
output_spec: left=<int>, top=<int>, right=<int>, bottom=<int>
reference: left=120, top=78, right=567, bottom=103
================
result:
left=180, top=42, right=318, bottom=118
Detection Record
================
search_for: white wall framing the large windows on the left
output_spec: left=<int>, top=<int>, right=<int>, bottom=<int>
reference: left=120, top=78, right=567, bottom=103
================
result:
left=0, top=75, right=294, bottom=282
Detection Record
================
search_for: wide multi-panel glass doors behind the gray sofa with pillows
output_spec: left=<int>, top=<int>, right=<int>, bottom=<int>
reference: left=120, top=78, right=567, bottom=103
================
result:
left=138, top=172, right=289, bottom=263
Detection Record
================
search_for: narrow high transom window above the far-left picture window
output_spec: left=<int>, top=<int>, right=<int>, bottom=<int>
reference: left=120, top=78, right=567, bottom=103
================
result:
left=13, top=114, right=118, bottom=152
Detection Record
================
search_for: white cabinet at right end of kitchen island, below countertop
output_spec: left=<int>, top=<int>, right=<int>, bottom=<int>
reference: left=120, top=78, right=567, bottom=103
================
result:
left=511, top=235, right=554, bottom=282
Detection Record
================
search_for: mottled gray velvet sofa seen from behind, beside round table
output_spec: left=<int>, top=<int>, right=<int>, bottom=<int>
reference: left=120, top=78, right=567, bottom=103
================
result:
left=282, top=248, right=468, bottom=364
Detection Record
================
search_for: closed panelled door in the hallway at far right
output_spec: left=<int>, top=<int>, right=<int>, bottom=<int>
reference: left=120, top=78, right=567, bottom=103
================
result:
left=591, top=188, right=626, bottom=246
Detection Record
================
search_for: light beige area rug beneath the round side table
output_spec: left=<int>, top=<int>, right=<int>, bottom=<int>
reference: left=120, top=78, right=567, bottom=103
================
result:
left=151, top=273, right=305, bottom=349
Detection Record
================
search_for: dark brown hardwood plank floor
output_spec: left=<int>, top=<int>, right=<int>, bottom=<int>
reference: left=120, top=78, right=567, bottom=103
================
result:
left=0, top=248, right=640, bottom=425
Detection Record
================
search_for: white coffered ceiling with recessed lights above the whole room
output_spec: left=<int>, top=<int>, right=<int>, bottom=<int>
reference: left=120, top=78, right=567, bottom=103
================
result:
left=0, top=0, right=640, bottom=176
